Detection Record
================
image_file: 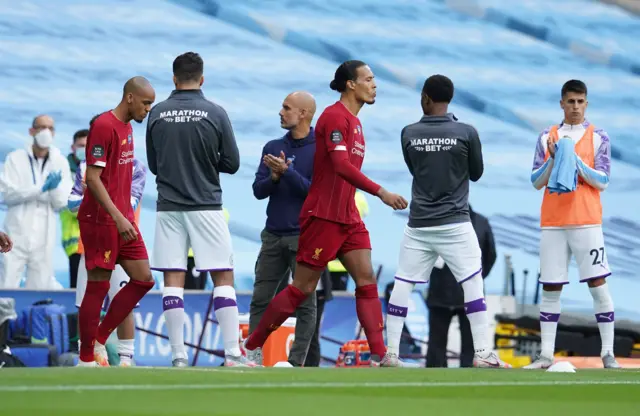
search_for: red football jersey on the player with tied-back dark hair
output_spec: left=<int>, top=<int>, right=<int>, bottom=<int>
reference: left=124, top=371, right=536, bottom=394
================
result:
left=300, top=101, right=365, bottom=224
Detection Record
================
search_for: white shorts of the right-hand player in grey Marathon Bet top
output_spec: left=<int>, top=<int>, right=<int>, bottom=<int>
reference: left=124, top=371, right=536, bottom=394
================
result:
left=395, top=222, right=482, bottom=283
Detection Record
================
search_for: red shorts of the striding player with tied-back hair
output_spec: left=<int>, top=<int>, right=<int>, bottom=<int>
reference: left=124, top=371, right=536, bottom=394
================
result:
left=296, top=217, right=371, bottom=270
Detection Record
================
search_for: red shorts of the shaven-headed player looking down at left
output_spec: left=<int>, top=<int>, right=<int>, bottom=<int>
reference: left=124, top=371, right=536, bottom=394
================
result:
left=80, top=221, right=149, bottom=270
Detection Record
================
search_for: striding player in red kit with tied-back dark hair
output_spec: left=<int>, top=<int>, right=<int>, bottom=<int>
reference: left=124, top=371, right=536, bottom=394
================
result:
left=244, top=61, right=407, bottom=367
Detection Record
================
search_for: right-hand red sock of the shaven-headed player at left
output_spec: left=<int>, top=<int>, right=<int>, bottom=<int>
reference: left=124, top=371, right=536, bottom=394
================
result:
left=96, top=279, right=155, bottom=344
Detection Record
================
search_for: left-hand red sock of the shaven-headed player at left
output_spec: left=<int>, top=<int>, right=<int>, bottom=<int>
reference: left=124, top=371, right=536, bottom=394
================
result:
left=78, top=280, right=109, bottom=362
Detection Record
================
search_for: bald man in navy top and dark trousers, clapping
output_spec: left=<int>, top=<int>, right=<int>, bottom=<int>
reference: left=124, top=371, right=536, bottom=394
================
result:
left=249, top=92, right=316, bottom=367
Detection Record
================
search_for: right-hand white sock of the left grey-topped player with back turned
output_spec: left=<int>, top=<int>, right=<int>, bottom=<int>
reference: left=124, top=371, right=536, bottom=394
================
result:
left=213, top=286, right=242, bottom=357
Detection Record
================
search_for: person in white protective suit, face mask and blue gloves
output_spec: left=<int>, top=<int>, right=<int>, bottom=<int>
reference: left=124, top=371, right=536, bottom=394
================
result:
left=0, top=114, right=72, bottom=289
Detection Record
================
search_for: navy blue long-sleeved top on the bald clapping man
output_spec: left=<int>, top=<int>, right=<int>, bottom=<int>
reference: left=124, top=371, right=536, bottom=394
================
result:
left=253, top=128, right=316, bottom=236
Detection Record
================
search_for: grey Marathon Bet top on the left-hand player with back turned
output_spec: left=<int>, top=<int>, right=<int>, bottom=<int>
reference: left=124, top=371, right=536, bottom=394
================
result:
left=147, top=90, right=240, bottom=211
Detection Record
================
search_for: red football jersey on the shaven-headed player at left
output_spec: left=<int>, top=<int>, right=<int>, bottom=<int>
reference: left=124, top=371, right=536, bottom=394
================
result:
left=78, top=111, right=134, bottom=224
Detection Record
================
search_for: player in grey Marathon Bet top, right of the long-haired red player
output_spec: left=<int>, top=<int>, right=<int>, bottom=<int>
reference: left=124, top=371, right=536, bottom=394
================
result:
left=387, top=75, right=510, bottom=368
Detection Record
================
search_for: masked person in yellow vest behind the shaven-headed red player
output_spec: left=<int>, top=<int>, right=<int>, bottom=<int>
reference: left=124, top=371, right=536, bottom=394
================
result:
left=60, top=129, right=89, bottom=289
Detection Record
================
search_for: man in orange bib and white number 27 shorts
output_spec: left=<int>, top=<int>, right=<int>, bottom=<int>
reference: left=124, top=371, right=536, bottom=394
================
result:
left=525, top=80, right=620, bottom=369
